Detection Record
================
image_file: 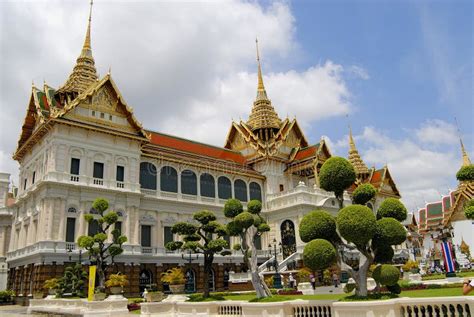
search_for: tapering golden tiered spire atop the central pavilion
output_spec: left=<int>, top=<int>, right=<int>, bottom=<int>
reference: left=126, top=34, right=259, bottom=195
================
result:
left=247, top=39, right=281, bottom=131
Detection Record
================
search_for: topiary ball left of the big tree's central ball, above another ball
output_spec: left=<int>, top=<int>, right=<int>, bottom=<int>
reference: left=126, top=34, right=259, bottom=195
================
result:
left=300, top=210, right=337, bottom=242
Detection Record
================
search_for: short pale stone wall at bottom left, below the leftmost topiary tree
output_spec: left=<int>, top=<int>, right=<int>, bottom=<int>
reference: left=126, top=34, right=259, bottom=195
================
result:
left=28, top=298, right=128, bottom=317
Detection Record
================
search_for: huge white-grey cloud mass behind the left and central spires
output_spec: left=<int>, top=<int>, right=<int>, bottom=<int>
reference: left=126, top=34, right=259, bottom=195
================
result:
left=0, top=1, right=356, bottom=178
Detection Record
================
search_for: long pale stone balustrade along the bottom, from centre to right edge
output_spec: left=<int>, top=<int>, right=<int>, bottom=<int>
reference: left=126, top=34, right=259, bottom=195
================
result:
left=141, top=296, right=474, bottom=317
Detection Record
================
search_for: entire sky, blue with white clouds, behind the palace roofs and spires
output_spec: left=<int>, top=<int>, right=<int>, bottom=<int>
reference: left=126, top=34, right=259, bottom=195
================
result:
left=0, top=0, right=474, bottom=210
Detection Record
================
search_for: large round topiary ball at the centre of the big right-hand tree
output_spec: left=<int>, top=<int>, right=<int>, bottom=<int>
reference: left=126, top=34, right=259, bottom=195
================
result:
left=336, top=205, right=377, bottom=246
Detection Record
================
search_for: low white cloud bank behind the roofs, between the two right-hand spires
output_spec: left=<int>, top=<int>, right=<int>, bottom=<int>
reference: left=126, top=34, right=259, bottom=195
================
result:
left=348, top=120, right=461, bottom=210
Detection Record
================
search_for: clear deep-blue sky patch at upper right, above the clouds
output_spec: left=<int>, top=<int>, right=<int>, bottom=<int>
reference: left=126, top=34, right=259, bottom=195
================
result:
left=288, top=1, right=474, bottom=143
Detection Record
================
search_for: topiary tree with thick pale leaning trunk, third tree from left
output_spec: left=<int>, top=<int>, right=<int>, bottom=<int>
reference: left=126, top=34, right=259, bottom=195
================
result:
left=224, top=199, right=271, bottom=298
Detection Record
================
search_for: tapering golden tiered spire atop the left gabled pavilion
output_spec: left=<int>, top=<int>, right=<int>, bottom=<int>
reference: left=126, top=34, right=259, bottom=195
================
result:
left=58, top=0, right=98, bottom=94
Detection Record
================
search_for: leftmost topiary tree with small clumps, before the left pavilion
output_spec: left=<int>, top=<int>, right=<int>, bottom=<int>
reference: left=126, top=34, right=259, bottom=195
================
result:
left=77, top=198, right=127, bottom=291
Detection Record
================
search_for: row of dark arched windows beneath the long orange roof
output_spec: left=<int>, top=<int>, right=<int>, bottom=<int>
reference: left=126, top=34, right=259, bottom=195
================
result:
left=140, top=162, right=262, bottom=201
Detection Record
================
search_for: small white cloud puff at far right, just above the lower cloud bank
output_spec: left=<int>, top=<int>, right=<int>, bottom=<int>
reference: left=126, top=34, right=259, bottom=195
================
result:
left=415, top=120, right=458, bottom=144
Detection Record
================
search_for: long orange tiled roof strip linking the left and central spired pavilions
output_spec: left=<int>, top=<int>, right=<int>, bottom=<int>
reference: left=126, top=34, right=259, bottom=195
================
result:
left=147, top=130, right=246, bottom=165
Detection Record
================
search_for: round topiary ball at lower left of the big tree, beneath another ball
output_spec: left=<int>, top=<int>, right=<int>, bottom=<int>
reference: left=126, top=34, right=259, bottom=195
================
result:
left=303, top=239, right=336, bottom=271
